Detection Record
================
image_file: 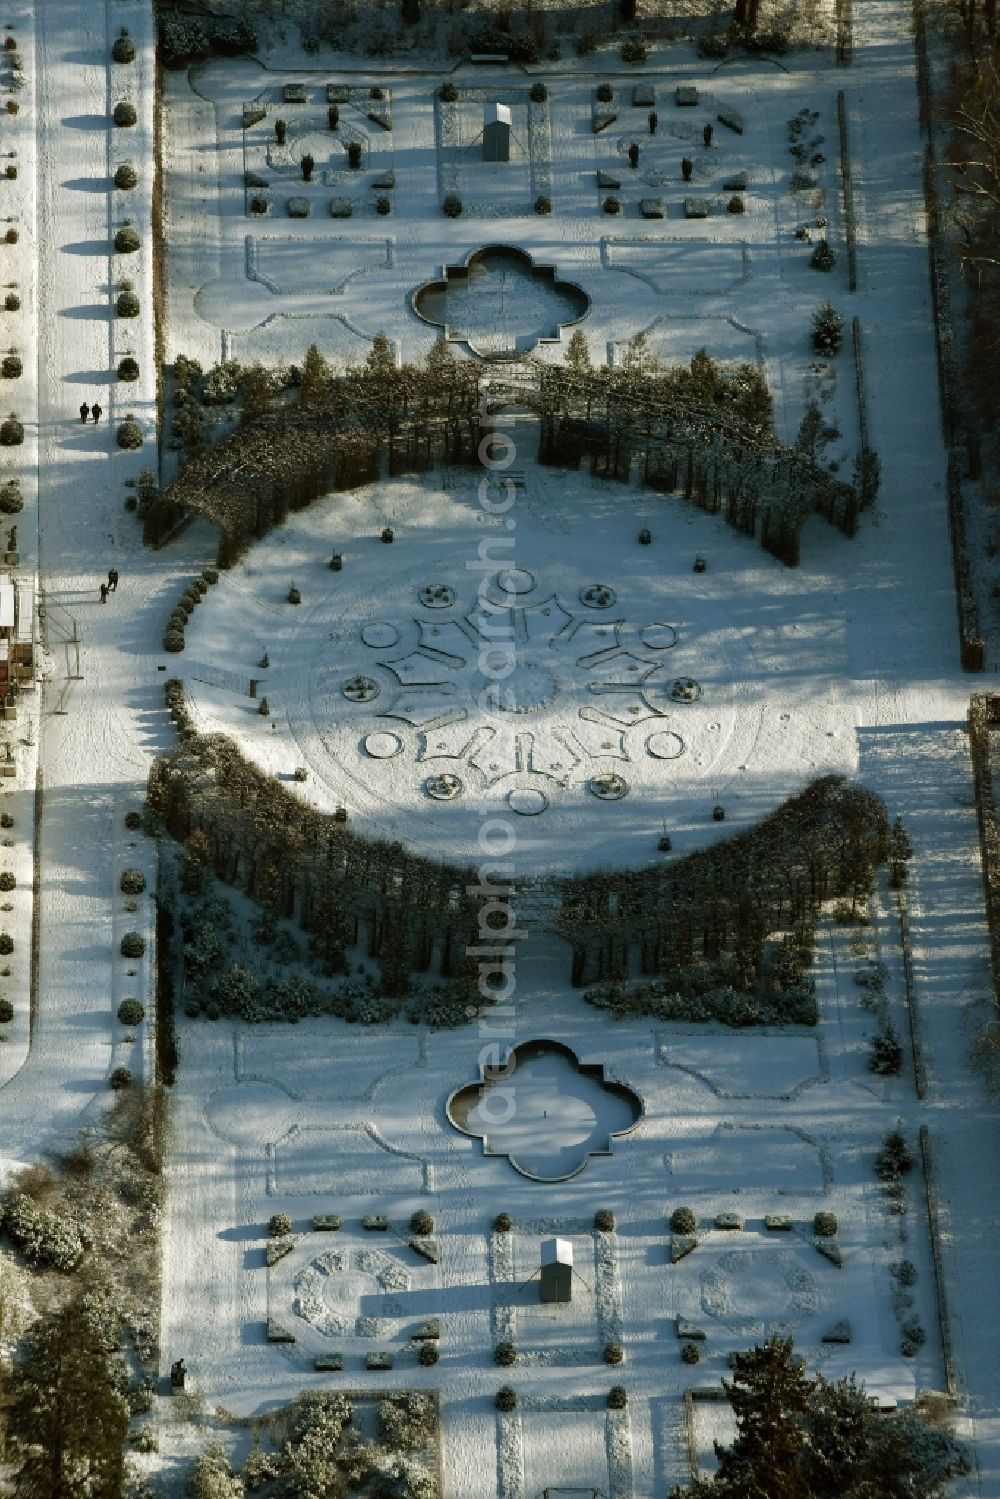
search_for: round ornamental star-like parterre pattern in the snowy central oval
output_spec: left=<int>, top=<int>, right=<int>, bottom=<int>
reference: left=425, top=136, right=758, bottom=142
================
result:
left=324, top=568, right=702, bottom=815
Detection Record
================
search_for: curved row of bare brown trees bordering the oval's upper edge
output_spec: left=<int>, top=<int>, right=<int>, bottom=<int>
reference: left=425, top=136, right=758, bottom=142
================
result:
left=144, top=330, right=861, bottom=565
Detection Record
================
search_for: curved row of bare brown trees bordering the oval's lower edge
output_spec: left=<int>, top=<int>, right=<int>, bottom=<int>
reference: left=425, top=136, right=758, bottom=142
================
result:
left=148, top=682, right=889, bottom=992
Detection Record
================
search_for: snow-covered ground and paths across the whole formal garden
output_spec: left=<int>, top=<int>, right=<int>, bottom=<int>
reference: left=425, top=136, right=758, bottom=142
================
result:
left=0, top=0, right=1000, bottom=1499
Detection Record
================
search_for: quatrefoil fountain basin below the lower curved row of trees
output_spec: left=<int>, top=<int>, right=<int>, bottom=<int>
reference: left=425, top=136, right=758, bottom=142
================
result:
left=447, top=1040, right=643, bottom=1181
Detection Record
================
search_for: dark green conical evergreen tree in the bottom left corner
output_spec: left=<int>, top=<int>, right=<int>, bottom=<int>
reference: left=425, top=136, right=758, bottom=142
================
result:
left=6, top=1304, right=129, bottom=1499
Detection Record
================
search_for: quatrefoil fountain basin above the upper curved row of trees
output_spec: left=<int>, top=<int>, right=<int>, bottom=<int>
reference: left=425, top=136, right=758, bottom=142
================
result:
left=412, top=244, right=591, bottom=358
